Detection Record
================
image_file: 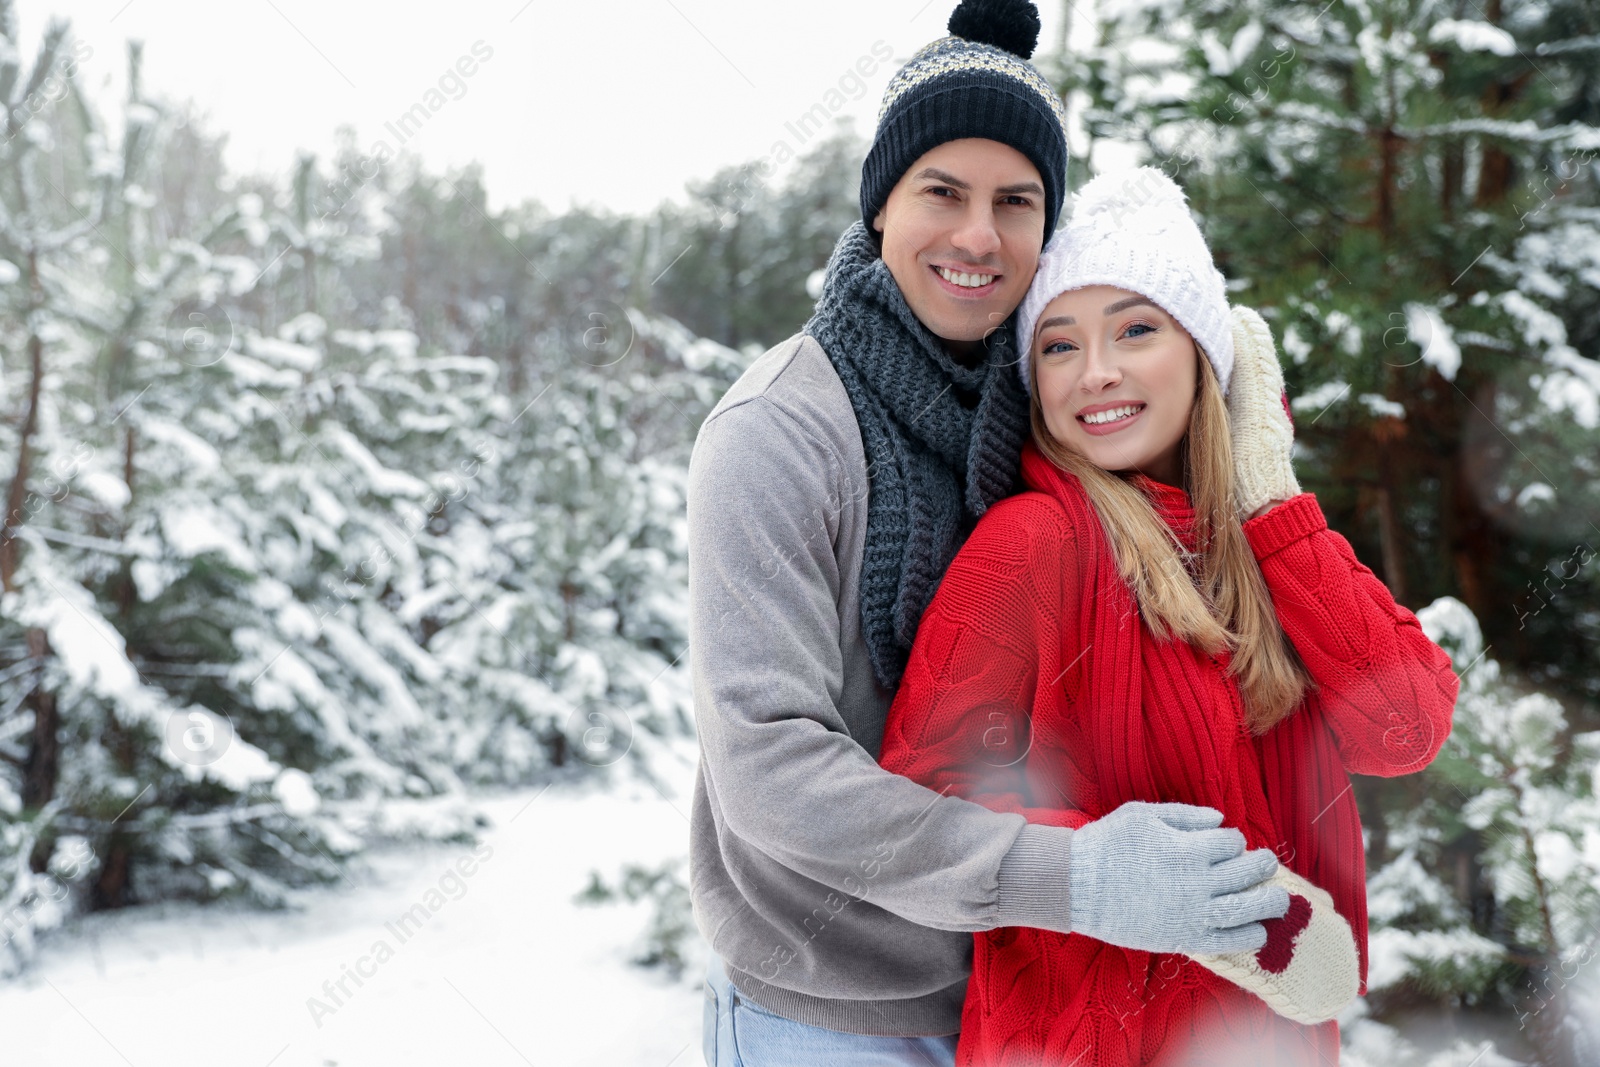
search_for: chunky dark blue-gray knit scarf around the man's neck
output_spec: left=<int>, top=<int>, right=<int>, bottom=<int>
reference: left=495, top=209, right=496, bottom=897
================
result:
left=805, top=221, right=1029, bottom=691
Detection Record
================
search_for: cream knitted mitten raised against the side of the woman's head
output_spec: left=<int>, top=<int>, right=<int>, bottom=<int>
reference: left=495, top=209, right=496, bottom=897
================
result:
left=1227, top=307, right=1301, bottom=518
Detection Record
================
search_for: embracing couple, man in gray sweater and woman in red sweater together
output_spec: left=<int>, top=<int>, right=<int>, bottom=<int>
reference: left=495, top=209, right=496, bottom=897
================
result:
left=688, top=0, right=1456, bottom=1067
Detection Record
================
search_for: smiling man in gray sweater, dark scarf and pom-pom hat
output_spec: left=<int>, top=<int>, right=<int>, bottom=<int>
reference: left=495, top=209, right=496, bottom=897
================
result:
left=688, top=0, right=1288, bottom=1067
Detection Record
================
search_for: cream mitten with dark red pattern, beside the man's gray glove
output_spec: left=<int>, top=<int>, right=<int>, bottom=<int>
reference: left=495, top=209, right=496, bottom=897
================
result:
left=1190, top=865, right=1360, bottom=1024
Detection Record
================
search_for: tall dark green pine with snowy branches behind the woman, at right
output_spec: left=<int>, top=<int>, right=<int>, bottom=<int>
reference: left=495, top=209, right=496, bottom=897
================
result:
left=1070, top=0, right=1600, bottom=699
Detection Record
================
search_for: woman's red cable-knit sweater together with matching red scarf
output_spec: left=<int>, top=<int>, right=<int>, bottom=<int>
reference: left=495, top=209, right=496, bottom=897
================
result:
left=880, top=443, right=1456, bottom=1067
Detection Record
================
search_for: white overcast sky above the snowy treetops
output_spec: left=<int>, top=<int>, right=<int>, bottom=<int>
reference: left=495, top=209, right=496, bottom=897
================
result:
left=19, top=0, right=1082, bottom=211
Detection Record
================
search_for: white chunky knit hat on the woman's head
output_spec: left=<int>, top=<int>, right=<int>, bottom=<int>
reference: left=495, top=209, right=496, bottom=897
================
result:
left=1016, top=166, right=1234, bottom=395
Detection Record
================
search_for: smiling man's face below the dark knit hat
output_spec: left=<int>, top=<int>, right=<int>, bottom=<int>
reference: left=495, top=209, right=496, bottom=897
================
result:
left=872, top=138, right=1045, bottom=352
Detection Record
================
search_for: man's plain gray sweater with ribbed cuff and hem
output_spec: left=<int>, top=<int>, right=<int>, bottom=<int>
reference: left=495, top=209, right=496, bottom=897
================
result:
left=688, top=334, right=1072, bottom=1035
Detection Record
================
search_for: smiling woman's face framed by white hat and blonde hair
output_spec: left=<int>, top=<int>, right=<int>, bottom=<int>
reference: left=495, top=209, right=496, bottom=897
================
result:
left=1032, top=285, right=1198, bottom=485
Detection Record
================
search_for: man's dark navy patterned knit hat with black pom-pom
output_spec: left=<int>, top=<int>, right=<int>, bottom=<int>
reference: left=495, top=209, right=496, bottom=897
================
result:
left=861, top=0, right=1067, bottom=238
